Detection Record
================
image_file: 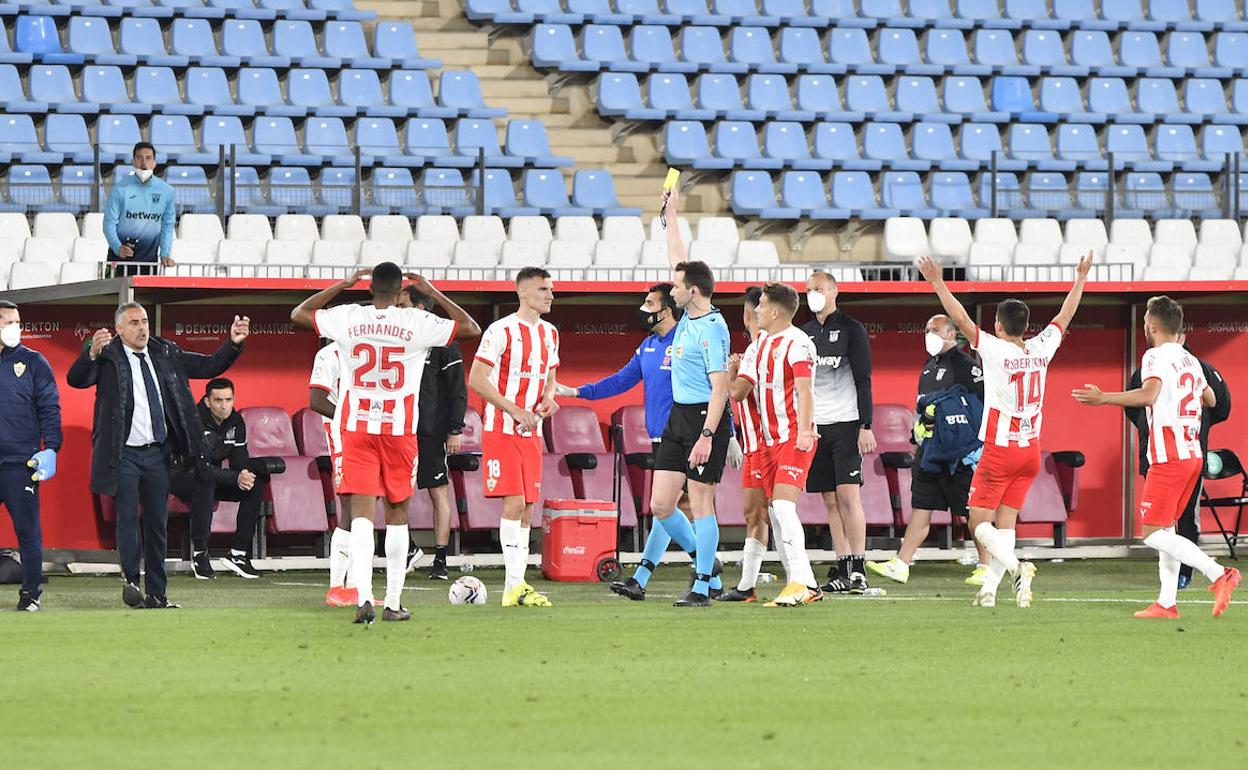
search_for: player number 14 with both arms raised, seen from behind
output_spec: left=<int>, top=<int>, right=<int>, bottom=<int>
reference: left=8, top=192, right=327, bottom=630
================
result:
left=919, top=252, right=1092, bottom=607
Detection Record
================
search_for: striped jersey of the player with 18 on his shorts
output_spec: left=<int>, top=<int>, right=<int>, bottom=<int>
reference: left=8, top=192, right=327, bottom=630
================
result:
left=477, top=313, right=559, bottom=436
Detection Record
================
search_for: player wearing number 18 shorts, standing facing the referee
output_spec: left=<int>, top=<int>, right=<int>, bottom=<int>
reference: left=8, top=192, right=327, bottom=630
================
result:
left=468, top=267, right=559, bottom=607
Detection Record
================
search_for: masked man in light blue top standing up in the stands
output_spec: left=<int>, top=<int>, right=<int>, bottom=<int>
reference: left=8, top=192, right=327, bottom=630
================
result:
left=104, top=142, right=177, bottom=275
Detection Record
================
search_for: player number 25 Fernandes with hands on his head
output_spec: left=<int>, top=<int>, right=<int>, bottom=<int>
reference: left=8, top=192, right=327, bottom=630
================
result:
left=291, top=262, right=480, bottom=623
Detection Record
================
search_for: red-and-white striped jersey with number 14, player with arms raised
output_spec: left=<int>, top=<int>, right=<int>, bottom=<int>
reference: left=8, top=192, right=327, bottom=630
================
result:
left=971, top=323, right=1062, bottom=447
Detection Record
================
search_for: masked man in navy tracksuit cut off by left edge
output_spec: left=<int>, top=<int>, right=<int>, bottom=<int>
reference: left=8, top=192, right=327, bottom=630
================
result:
left=0, top=301, right=61, bottom=613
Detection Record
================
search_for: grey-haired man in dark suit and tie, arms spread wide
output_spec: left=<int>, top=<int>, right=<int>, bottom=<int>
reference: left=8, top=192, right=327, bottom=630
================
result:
left=66, top=302, right=250, bottom=609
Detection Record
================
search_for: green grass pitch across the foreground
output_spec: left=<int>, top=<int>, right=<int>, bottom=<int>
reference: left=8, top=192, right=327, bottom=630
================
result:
left=0, top=562, right=1248, bottom=770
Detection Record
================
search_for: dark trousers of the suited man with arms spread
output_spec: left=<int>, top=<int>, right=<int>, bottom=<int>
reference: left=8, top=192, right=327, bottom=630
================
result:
left=114, top=446, right=168, bottom=598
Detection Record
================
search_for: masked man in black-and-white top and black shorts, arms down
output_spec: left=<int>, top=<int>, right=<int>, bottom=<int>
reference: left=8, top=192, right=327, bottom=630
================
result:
left=801, top=270, right=875, bottom=594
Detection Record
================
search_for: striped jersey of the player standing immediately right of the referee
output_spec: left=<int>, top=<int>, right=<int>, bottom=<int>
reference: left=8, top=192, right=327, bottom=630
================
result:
left=740, top=326, right=815, bottom=447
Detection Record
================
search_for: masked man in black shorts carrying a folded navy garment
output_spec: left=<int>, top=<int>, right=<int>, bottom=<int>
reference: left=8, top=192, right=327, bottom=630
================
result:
left=866, top=314, right=988, bottom=585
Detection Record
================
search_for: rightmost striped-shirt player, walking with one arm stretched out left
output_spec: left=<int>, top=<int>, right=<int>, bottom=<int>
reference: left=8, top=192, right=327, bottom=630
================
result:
left=1072, top=296, right=1239, bottom=618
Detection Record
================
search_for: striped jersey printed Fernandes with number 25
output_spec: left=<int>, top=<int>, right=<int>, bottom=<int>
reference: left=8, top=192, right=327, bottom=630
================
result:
left=314, top=305, right=457, bottom=436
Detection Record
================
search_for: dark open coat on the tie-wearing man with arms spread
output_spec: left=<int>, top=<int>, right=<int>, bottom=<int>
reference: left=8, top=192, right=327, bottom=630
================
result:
left=65, top=337, right=242, bottom=497
